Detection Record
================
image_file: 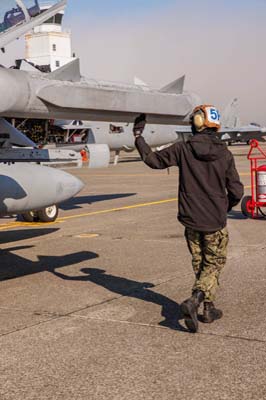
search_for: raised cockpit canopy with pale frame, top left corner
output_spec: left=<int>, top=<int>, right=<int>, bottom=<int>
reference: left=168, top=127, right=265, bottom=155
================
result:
left=0, top=0, right=67, bottom=49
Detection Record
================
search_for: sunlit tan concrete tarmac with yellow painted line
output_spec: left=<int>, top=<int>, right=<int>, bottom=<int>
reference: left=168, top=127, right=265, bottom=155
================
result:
left=0, top=146, right=266, bottom=400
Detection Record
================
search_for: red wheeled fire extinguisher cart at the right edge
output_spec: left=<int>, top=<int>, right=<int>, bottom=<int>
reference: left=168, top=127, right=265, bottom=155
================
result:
left=241, top=139, right=266, bottom=218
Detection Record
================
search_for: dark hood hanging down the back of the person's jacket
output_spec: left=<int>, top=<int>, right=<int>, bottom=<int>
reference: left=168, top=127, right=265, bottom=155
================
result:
left=188, top=132, right=227, bottom=161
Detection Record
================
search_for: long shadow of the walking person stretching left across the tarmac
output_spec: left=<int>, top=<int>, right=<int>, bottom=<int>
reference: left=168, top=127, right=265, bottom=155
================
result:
left=53, top=268, right=187, bottom=332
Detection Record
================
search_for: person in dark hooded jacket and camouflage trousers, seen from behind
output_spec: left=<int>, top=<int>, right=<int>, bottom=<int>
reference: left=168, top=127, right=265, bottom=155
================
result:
left=133, top=105, right=243, bottom=333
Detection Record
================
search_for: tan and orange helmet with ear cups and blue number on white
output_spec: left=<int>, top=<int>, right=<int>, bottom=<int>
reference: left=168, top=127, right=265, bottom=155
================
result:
left=190, top=104, right=221, bottom=132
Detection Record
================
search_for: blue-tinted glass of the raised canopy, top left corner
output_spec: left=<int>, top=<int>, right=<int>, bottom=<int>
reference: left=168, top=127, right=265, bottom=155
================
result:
left=0, top=0, right=40, bottom=33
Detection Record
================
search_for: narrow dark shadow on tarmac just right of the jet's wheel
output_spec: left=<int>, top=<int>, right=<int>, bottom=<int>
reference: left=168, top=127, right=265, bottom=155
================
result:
left=60, top=193, right=136, bottom=210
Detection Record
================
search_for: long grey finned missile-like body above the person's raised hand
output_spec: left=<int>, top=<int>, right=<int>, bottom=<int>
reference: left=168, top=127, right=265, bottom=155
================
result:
left=0, top=59, right=200, bottom=125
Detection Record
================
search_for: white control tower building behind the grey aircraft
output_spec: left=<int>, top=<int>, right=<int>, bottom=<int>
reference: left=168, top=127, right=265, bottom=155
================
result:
left=25, top=1, right=75, bottom=71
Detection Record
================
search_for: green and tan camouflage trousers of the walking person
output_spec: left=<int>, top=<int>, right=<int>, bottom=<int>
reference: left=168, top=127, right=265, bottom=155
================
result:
left=185, top=228, right=229, bottom=302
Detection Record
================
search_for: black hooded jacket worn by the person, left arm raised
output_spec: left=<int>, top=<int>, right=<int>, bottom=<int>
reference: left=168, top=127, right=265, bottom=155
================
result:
left=136, top=130, right=243, bottom=232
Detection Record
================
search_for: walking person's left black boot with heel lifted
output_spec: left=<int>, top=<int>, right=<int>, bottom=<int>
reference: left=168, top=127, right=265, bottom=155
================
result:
left=181, top=290, right=205, bottom=333
